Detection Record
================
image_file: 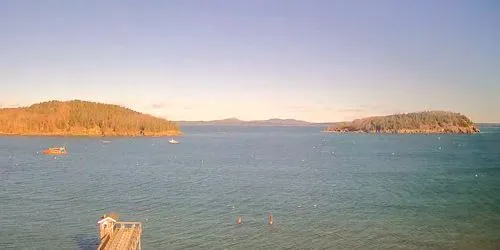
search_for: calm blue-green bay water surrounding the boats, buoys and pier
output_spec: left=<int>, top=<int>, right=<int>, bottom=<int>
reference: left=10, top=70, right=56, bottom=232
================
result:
left=0, top=126, right=500, bottom=249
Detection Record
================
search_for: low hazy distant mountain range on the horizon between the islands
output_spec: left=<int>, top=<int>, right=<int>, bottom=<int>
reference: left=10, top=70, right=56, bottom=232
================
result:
left=177, top=118, right=332, bottom=127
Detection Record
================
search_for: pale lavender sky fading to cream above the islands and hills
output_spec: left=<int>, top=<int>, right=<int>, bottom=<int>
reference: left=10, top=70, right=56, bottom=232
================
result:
left=0, top=0, right=500, bottom=122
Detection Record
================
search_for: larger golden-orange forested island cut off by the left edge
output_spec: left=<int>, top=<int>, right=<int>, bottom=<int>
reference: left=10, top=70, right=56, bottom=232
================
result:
left=0, top=100, right=181, bottom=136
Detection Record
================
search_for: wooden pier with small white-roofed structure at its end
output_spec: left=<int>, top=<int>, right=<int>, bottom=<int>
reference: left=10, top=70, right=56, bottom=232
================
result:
left=97, top=215, right=142, bottom=250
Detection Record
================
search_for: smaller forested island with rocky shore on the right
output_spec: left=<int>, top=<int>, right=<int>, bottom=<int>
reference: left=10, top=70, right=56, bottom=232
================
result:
left=326, top=111, right=479, bottom=134
